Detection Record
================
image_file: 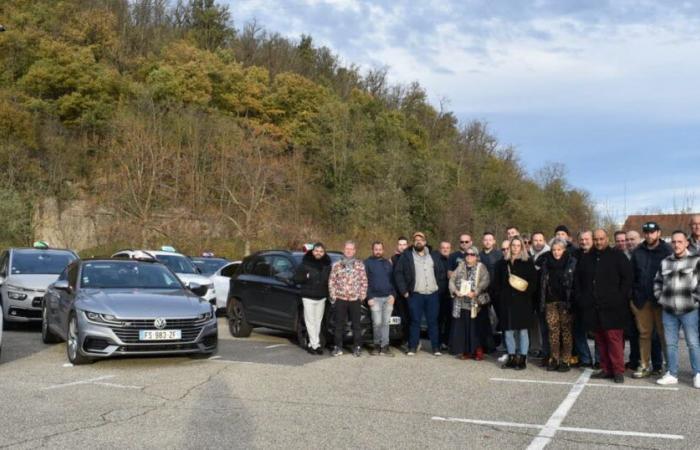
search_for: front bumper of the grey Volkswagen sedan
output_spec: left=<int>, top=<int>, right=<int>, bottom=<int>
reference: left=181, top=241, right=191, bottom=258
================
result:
left=78, top=314, right=218, bottom=358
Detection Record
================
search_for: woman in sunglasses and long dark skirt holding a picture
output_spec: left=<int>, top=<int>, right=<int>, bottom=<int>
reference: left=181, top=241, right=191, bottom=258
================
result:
left=450, top=247, right=491, bottom=361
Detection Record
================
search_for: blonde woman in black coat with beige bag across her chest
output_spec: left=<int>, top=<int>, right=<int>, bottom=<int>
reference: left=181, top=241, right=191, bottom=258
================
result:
left=494, top=236, right=537, bottom=370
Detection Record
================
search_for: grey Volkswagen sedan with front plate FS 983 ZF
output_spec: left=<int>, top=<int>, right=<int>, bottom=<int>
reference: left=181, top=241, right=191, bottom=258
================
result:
left=41, top=259, right=218, bottom=364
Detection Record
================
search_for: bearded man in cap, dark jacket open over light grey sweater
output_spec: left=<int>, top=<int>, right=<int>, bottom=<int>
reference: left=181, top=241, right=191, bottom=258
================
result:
left=394, top=231, right=447, bottom=356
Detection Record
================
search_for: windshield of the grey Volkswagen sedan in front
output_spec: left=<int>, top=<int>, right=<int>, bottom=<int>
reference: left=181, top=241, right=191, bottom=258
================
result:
left=80, top=261, right=182, bottom=289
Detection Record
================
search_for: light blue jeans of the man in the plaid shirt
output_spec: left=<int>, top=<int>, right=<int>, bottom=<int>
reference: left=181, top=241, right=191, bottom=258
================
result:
left=661, top=309, right=700, bottom=377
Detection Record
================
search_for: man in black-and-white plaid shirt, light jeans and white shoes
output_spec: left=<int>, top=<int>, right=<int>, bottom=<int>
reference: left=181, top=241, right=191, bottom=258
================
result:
left=654, top=230, right=700, bottom=389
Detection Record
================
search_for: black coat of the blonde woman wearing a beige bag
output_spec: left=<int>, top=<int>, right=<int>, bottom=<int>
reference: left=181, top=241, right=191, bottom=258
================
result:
left=491, top=259, right=537, bottom=330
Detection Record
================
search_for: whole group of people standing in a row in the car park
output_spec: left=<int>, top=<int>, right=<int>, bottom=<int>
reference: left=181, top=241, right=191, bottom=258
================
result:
left=295, top=215, right=700, bottom=388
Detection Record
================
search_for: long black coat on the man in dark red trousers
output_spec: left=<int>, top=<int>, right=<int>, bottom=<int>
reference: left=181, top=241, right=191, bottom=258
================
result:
left=574, top=248, right=632, bottom=331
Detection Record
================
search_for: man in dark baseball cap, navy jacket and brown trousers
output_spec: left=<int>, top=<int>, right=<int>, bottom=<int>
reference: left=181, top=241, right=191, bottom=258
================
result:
left=631, top=222, right=673, bottom=378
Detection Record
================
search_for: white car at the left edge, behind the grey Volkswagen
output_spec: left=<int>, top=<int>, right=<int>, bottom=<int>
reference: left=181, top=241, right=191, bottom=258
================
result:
left=0, top=246, right=78, bottom=322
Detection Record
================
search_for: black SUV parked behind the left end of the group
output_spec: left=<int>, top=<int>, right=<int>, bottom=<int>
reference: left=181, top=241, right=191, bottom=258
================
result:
left=226, top=250, right=402, bottom=348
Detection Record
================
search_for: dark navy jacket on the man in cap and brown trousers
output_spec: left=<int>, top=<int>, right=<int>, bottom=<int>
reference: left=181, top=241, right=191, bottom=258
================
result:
left=631, top=241, right=673, bottom=309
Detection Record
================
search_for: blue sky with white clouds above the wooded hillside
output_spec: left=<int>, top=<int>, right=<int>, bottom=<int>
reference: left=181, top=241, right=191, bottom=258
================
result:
left=222, top=0, right=700, bottom=222
